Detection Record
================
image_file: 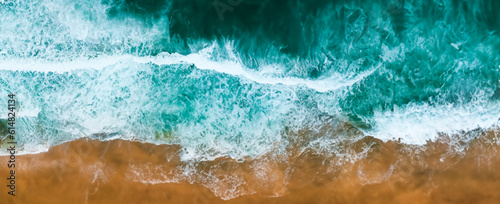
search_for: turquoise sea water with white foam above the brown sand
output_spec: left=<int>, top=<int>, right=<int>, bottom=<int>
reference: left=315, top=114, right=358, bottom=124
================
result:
left=0, top=0, right=500, bottom=159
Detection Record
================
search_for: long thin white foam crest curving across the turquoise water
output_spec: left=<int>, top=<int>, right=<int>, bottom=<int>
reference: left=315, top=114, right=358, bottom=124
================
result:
left=0, top=42, right=376, bottom=92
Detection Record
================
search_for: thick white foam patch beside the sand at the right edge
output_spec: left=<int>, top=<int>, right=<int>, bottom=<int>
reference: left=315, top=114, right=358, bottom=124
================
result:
left=366, top=103, right=500, bottom=145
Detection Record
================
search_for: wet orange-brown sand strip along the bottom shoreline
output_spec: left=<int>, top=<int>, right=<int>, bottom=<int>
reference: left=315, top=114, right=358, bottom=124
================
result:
left=0, top=131, right=500, bottom=204
